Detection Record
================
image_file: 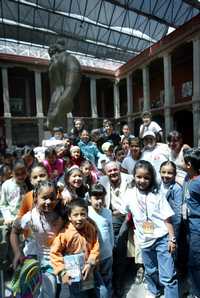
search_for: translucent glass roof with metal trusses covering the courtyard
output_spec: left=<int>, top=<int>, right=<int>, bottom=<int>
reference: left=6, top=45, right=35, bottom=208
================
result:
left=0, top=0, right=200, bottom=70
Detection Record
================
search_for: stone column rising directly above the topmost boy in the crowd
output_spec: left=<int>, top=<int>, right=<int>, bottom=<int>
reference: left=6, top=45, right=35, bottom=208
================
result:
left=142, top=66, right=151, bottom=111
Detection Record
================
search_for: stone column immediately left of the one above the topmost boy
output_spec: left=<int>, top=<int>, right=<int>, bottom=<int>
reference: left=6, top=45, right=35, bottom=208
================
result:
left=126, top=74, right=134, bottom=129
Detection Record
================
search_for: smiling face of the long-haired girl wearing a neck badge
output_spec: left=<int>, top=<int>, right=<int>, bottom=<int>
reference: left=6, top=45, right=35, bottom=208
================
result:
left=134, top=168, right=151, bottom=191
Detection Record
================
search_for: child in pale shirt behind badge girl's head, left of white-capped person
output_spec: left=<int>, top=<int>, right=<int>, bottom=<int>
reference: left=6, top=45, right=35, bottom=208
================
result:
left=122, top=138, right=142, bottom=175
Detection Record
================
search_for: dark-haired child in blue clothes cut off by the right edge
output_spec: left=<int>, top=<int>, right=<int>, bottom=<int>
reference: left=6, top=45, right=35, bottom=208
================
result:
left=182, top=148, right=200, bottom=297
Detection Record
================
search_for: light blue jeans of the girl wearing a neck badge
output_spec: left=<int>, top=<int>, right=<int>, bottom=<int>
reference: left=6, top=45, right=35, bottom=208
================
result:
left=142, top=236, right=179, bottom=298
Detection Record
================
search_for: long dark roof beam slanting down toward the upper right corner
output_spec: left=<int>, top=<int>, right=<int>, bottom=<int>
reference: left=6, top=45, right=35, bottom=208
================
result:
left=104, top=0, right=178, bottom=28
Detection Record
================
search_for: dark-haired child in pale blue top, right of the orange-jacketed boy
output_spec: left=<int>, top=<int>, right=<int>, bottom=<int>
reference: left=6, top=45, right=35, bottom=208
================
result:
left=88, top=183, right=114, bottom=297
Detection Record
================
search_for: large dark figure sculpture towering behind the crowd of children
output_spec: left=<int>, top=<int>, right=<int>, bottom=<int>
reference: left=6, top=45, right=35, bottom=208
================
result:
left=47, top=40, right=81, bottom=129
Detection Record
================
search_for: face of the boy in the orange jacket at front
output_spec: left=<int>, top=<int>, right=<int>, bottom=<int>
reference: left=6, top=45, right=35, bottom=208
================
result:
left=69, top=206, right=87, bottom=230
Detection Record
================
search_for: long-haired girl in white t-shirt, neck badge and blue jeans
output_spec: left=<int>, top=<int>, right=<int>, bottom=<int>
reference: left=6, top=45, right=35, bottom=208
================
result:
left=125, top=160, right=178, bottom=298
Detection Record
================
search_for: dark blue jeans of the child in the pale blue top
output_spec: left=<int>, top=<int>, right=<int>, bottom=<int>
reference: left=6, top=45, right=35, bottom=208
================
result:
left=95, top=257, right=112, bottom=298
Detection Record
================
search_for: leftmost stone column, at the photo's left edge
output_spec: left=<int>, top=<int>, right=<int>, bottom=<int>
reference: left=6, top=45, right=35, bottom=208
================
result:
left=1, top=68, right=12, bottom=147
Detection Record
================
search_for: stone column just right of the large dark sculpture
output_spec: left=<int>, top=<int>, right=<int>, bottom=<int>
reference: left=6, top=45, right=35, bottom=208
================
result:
left=90, top=78, right=98, bottom=128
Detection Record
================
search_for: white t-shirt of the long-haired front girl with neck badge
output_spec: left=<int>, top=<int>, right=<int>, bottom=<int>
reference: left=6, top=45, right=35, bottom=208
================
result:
left=124, top=187, right=174, bottom=248
